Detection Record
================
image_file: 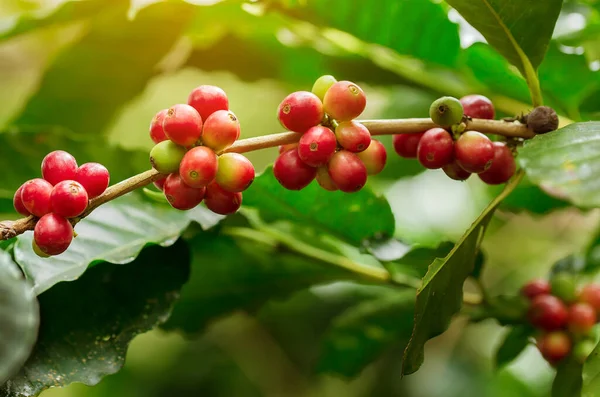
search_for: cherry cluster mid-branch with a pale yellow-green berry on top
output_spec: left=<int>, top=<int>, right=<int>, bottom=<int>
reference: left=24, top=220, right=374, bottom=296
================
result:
left=273, top=75, right=387, bottom=193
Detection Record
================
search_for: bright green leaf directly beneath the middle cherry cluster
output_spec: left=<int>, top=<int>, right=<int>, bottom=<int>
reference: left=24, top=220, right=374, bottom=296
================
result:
left=243, top=167, right=394, bottom=246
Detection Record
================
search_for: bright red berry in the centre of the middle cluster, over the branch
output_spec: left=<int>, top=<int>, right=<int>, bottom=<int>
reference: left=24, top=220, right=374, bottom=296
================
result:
left=298, top=125, right=337, bottom=167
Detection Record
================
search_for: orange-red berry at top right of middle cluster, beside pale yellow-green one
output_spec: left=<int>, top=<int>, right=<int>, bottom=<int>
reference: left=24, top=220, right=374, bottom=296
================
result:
left=323, top=80, right=367, bottom=122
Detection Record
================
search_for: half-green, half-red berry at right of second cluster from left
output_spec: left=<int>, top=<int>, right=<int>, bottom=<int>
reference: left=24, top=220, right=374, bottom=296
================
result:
left=215, top=153, right=255, bottom=193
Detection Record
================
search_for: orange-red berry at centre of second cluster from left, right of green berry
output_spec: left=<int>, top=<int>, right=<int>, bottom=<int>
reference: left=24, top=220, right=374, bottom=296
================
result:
left=179, top=146, right=219, bottom=188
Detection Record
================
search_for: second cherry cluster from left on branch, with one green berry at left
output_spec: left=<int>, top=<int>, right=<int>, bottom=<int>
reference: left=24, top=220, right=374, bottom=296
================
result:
left=150, top=85, right=255, bottom=215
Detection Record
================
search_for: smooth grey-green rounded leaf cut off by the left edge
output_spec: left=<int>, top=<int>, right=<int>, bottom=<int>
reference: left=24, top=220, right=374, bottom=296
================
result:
left=0, top=251, right=39, bottom=384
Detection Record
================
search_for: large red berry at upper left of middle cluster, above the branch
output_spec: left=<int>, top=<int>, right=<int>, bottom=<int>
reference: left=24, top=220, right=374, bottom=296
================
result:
left=277, top=91, right=325, bottom=133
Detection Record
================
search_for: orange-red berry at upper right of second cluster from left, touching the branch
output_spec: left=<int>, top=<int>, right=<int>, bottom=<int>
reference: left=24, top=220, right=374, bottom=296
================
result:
left=202, top=110, right=240, bottom=152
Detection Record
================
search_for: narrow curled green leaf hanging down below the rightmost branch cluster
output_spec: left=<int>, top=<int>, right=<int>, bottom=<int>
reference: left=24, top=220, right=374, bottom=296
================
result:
left=402, top=173, right=523, bottom=374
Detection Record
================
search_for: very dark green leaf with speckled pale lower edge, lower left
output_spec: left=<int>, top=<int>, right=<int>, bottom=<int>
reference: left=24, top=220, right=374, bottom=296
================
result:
left=0, top=241, right=190, bottom=397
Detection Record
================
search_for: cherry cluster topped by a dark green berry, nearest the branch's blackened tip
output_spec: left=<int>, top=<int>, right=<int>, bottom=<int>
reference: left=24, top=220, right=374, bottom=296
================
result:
left=393, top=95, right=516, bottom=185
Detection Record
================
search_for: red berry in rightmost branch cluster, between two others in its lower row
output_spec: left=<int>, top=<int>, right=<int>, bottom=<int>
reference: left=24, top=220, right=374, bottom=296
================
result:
left=454, top=131, right=494, bottom=174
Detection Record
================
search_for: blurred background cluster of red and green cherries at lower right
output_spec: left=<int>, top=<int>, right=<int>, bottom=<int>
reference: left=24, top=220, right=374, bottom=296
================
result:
left=521, top=273, right=600, bottom=365
